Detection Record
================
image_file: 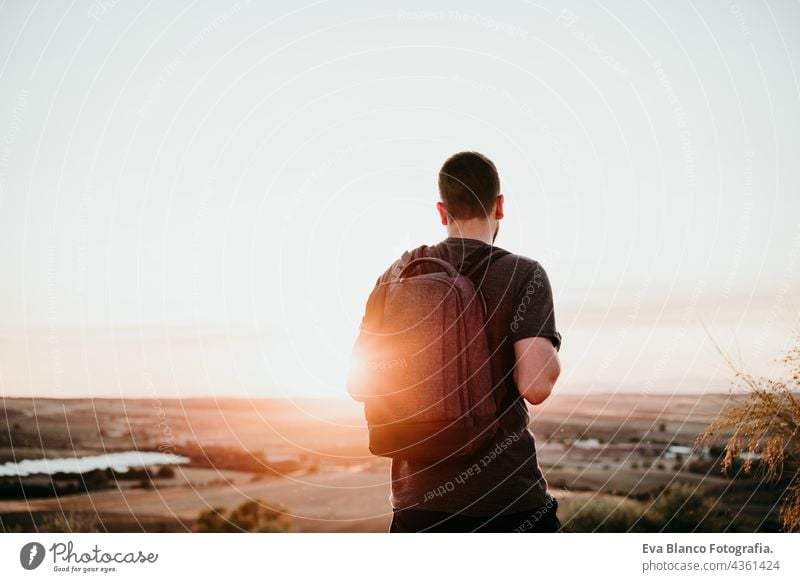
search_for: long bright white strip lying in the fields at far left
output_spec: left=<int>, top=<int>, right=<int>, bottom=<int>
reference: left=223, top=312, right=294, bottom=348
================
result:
left=0, top=451, right=189, bottom=477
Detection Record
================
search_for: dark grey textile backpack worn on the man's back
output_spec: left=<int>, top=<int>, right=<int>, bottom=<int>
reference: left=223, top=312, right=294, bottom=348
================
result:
left=348, top=246, right=509, bottom=461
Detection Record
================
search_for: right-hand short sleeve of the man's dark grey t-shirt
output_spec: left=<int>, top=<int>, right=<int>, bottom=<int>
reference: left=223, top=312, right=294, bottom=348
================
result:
left=510, top=261, right=561, bottom=350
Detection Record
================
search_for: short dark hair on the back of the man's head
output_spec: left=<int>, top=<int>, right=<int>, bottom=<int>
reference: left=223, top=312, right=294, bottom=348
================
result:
left=439, top=152, right=500, bottom=219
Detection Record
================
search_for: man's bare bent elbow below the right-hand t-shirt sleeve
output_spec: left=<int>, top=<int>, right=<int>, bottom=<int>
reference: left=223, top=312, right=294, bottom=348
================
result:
left=514, top=337, right=561, bottom=404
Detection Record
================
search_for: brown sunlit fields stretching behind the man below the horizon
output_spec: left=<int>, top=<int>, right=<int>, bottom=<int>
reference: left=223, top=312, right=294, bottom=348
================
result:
left=0, top=394, right=778, bottom=532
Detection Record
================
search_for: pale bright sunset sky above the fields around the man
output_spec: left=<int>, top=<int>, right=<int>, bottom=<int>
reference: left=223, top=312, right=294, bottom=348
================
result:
left=0, top=0, right=800, bottom=397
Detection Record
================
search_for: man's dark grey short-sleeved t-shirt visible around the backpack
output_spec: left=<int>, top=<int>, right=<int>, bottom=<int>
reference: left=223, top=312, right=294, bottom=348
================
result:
left=376, top=237, right=561, bottom=516
